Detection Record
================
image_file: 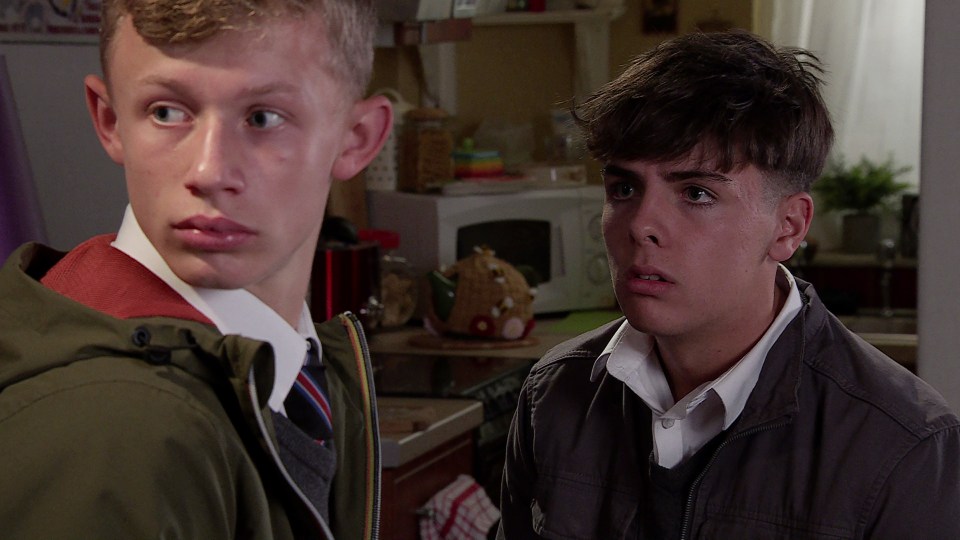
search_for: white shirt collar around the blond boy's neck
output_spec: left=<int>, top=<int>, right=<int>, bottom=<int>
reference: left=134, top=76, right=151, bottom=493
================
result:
left=112, top=205, right=322, bottom=412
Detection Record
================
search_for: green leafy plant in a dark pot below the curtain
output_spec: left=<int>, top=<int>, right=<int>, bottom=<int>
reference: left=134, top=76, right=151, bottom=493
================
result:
left=813, top=157, right=911, bottom=253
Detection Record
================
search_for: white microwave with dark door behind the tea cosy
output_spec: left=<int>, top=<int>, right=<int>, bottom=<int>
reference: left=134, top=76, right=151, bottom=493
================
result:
left=367, top=185, right=616, bottom=314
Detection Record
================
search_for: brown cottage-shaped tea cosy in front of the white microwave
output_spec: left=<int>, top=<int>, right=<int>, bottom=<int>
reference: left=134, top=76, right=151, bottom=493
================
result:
left=425, top=248, right=536, bottom=340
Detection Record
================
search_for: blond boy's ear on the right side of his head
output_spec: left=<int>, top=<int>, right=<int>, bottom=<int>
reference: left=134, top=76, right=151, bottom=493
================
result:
left=332, top=96, right=393, bottom=180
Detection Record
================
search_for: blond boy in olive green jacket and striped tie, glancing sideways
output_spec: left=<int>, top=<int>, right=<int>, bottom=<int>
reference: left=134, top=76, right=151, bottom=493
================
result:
left=0, top=0, right=391, bottom=539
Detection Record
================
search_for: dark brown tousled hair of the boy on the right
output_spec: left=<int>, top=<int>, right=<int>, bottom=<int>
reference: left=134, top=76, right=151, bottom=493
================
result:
left=574, top=31, right=833, bottom=193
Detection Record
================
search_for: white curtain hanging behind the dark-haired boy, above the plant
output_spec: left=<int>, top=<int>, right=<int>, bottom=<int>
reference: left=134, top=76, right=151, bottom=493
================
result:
left=755, top=0, right=924, bottom=249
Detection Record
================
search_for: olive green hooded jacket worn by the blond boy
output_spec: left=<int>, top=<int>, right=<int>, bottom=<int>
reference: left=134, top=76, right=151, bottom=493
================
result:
left=0, top=245, right=380, bottom=540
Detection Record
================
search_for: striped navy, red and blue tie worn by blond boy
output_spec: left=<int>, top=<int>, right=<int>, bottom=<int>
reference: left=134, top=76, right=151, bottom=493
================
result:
left=283, top=339, right=333, bottom=445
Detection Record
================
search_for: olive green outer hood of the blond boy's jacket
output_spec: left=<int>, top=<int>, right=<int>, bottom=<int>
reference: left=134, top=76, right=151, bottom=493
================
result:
left=0, top=244, right=273, bottom=405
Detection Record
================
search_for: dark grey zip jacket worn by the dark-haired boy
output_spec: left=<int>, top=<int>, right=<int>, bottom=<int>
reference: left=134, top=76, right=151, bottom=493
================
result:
left=499, top=282, right=960, bottom=540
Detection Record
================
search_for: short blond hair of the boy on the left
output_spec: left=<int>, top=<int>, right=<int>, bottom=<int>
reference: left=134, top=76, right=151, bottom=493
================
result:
left=100, top=0, right=377, bottom=96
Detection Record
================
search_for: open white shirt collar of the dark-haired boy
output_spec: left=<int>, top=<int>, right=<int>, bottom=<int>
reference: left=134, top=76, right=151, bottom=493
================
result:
left=591, top=265, right=803, bottom=429
